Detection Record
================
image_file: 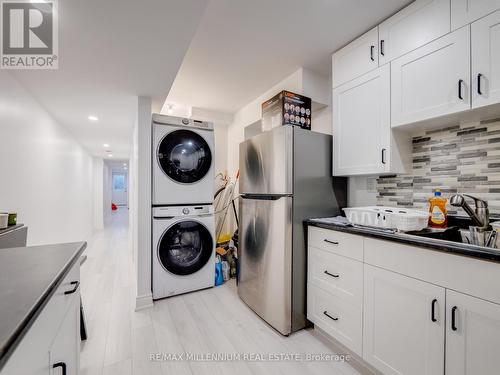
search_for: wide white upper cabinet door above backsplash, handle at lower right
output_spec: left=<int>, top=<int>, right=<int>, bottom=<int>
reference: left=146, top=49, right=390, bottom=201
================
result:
left=391, top=26, right=470, bottom=127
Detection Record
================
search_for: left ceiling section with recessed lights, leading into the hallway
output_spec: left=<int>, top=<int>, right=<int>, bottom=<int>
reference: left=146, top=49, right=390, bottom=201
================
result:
left=13, top=0, right=206, bottom=159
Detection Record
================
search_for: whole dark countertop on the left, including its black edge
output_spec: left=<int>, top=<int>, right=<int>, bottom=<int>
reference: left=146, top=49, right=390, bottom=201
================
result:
left=0, top=242, right=87, bottom=369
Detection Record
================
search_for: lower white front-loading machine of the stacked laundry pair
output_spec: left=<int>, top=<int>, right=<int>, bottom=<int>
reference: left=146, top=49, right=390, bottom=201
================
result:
left=152, top=205, right=215, bottom=299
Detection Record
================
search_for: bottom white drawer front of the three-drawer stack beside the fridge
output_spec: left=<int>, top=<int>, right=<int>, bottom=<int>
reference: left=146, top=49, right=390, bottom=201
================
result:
left=307, top=284, right=363, bottom=356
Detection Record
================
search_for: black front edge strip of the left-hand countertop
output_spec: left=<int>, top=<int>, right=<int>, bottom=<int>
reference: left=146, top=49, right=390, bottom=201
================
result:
left=0, top=242, right=87, bottom=371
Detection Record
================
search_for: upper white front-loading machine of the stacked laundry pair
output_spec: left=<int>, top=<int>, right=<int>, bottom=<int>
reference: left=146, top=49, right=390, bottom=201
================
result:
left=152, top=114, right=215, bottom=206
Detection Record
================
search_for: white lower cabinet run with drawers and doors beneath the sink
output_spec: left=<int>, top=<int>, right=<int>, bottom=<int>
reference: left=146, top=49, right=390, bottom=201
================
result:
left=307, top=226, right=500, bottom=375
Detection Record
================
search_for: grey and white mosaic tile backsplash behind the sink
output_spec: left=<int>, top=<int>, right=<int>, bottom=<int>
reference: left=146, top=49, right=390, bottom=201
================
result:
left=377, top=119, right=500, bottom=215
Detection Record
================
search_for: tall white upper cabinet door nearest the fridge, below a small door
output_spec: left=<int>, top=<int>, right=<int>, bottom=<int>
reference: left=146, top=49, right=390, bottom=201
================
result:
left=333, top=65, right=391, bottom=176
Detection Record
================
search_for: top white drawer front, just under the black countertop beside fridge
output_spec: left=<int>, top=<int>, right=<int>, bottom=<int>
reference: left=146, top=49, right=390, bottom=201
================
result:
left=308, top=226, right=363, bottom=261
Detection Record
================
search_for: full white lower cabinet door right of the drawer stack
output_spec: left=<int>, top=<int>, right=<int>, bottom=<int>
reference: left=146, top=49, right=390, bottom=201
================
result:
left=363, top=264, right=445, bottom=375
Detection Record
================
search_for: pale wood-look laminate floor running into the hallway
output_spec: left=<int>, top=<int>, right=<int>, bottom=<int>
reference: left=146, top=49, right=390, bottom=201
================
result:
left=80, top=208, right=359, bottom=375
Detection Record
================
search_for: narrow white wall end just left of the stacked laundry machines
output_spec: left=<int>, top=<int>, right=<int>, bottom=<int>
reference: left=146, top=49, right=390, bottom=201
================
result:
left=129, top=97, right=153, bottom=309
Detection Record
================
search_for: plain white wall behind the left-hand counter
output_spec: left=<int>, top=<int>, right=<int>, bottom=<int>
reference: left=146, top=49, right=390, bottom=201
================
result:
left=0, top=71, right=94, bottom=245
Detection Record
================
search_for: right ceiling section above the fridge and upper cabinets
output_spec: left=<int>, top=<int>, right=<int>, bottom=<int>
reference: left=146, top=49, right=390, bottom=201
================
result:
left=167, top=0, right=411, bottom=113
